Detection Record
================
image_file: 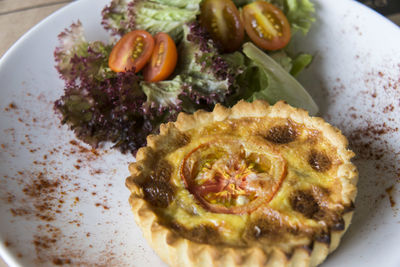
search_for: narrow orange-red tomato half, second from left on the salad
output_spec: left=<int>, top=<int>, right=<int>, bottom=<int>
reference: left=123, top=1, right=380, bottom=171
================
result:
left=143, top=32, right=178, bottom=82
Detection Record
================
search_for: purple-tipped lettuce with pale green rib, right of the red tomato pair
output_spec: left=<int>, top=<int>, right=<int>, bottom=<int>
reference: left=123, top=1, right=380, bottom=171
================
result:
left=177, top=23, right=240, bottom=111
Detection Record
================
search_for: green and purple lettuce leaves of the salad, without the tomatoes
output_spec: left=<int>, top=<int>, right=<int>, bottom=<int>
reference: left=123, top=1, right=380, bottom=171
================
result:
left=54, top=0, right=318, bottom=153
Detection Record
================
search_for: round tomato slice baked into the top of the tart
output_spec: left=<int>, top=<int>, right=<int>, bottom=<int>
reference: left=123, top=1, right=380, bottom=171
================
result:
left=181, top=139, right=287, bottom=214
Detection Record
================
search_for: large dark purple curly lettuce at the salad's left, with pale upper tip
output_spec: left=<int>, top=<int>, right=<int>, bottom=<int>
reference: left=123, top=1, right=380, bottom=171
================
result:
left=54, top=22, right=158, bottom=153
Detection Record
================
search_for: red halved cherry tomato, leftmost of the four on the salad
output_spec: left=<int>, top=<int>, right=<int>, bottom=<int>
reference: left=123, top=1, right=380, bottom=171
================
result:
left=108, top=30, right=154, bottom=72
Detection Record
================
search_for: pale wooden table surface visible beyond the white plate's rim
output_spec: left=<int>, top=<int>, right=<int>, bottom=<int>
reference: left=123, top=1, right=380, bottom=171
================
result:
left=0, top=0, right=400, bottom=267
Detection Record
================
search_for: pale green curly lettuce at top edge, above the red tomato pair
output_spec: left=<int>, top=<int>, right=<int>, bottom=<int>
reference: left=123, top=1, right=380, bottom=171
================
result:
left=102, top=0, right=201, bottom=41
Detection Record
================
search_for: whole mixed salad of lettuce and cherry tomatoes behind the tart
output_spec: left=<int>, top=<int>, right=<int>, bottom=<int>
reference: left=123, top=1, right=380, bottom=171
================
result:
left=54, top=0, right=318, bottom=153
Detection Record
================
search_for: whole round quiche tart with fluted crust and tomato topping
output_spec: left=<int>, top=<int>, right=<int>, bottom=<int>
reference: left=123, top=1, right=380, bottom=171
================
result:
left=126, top=101, right=358, bottom=266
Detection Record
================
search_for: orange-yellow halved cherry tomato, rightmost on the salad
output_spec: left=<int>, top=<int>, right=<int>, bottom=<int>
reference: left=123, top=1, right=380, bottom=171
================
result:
left=242, top=1, right=291, bottom=50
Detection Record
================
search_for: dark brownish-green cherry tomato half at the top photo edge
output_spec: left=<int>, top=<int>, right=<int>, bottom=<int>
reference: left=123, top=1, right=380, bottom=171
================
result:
left=200, top=0, right=244, bottom=52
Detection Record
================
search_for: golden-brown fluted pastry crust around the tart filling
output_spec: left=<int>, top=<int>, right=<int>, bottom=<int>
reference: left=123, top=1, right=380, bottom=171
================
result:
left=126, top=101, right=358, bottom=266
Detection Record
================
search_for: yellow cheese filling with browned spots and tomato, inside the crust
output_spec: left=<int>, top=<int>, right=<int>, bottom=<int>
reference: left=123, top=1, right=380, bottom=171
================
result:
left=148, top=118, right=345, bottom=246
